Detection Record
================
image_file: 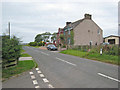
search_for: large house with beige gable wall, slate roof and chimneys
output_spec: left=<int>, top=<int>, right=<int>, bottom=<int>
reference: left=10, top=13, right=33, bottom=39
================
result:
left=63, top=14, right=103, bottom=46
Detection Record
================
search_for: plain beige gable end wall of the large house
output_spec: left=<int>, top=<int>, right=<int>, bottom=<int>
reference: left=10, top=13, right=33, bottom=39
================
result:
left=73, top=19, right=103, bottom=45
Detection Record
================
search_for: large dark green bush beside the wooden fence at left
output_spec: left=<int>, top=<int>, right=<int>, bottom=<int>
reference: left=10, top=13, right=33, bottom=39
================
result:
left=2, top=35, right=21, bottom=68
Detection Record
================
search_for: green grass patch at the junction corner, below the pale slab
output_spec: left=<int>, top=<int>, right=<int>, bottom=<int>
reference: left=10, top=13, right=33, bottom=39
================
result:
left=2, top=60, right=36, bottom=78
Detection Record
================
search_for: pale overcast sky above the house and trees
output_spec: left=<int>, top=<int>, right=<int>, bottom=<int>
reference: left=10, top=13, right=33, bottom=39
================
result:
left=0, top=0, right=119, bottom=42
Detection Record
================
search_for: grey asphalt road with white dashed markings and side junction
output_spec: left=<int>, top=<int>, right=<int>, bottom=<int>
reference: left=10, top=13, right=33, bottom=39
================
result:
left=3, top=46, right=120, bottom=88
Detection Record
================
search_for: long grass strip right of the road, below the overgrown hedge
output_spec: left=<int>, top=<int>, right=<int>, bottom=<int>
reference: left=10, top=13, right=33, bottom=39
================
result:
left=60, top=50, right=118, bottom=65
